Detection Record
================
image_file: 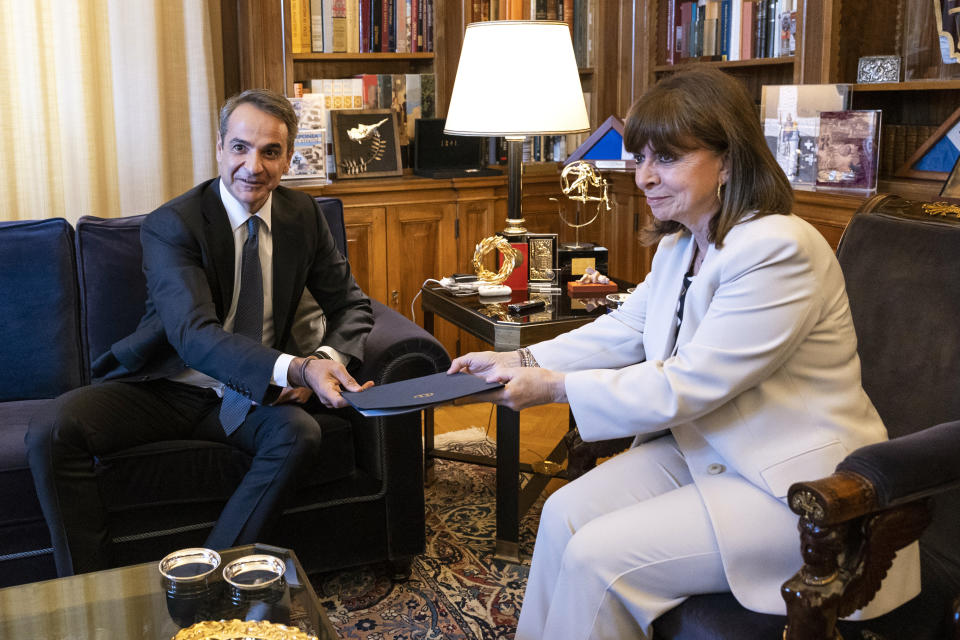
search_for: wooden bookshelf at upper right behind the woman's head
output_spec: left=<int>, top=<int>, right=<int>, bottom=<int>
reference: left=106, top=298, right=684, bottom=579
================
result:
left=634, top=0, right=960, bottom=202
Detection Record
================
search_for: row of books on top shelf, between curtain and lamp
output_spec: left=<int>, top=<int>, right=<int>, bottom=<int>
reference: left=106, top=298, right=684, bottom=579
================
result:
left=290, top=0, right=433, bottom=53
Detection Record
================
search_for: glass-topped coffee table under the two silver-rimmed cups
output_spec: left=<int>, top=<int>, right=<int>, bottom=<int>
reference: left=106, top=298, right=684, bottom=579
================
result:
left=0, top=544, right=338, bottom=640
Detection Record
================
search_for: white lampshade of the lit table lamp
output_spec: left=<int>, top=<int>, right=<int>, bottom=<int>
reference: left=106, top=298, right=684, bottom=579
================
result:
left=444, top=20, right=590, bottom=137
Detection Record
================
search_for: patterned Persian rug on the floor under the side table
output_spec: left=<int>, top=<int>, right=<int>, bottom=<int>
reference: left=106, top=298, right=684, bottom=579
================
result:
left=312, top=428, right=543, bottom=640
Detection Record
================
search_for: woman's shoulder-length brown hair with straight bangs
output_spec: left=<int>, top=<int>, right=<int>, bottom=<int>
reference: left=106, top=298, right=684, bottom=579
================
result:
left=623, top=66, right=793, bottom=247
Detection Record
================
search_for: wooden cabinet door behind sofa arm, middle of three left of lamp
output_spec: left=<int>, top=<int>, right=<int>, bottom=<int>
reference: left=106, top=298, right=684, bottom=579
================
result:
left=386, top=202, right=457, bottom=353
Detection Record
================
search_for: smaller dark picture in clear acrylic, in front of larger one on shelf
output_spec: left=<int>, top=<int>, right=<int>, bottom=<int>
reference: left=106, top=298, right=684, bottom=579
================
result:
left=817, top=110, right=882, bottom=191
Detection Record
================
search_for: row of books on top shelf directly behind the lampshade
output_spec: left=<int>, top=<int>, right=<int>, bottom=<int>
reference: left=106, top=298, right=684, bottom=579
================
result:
left=467, top=0, right=593, bottom=69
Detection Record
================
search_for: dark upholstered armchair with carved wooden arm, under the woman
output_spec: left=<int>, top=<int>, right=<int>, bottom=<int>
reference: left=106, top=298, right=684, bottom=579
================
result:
left=568, top=195, right=960, bottom=640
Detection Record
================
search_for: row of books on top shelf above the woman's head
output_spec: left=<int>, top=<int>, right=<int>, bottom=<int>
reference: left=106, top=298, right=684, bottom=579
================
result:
left=665, top=0, right=797, bottom=64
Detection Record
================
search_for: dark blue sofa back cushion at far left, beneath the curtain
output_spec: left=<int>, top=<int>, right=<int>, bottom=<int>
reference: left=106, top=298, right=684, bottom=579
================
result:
left=0, top=218, right=87, bottom=402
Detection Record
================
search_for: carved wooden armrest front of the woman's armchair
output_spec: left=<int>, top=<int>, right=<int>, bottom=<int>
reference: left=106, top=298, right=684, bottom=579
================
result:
left=781, top=471, right=930, bottom=640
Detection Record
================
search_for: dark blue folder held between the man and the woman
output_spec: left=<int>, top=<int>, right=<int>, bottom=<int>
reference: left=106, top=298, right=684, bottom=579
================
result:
left=343, top=372, right=503, bottom=416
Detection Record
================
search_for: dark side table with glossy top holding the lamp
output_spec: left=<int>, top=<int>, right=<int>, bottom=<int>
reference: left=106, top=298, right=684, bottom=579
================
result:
left=421, top=286, right=624, bottom=562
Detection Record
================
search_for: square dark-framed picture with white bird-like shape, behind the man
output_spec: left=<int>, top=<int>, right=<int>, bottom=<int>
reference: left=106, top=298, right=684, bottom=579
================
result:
left=330, top=109, right=403, bottom=180
